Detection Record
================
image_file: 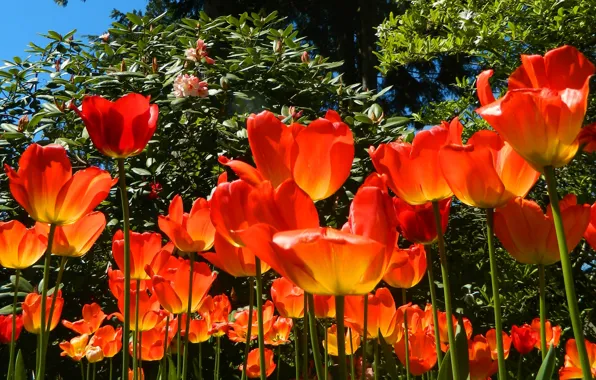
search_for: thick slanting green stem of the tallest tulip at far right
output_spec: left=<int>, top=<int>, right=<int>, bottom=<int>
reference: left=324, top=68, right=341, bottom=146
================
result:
left=544, top=166, right=592, bottom=379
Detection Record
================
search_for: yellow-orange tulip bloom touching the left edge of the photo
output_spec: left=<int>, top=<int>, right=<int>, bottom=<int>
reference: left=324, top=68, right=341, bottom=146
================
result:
left=0, top=220, right=48, bottom=269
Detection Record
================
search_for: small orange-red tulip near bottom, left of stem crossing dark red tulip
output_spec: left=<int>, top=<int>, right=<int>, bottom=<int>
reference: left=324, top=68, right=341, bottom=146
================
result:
left=395, top=330, right=437, bottom=376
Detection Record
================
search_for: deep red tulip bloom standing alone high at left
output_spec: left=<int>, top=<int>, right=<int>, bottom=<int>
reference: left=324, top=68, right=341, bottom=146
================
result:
left=71, top=93, right=158, bottom=158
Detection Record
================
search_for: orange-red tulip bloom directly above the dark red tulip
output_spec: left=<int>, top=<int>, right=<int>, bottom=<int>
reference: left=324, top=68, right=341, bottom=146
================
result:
left=368, top=119, right=462, bottom=205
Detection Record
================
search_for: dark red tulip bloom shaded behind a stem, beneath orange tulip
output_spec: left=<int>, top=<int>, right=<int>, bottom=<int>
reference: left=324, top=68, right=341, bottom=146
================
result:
left=393, top=197, right=451, bottom=244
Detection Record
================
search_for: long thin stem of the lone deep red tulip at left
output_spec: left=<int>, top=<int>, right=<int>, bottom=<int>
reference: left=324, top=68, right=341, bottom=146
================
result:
left=116, top=158, right=131, bottom=377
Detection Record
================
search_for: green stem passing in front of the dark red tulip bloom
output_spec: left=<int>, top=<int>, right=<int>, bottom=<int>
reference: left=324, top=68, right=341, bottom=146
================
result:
left=433, top=201, right=460, bottom=380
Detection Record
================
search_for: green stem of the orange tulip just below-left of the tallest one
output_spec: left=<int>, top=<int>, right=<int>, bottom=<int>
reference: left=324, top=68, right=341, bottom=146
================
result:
left=486, top=208, right=507, bottom=380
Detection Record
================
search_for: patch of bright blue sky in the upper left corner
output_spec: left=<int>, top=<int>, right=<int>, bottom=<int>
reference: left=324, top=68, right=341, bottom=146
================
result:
left=0, top=0, right=147, bottom=60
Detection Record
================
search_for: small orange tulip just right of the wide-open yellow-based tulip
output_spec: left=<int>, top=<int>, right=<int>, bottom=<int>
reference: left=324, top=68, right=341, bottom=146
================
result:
left=383, top=244, right=426, bottom=289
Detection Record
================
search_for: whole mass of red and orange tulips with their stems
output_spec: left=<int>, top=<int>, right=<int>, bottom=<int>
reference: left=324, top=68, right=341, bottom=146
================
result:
left=0, top=42, right=596, bottom=380
